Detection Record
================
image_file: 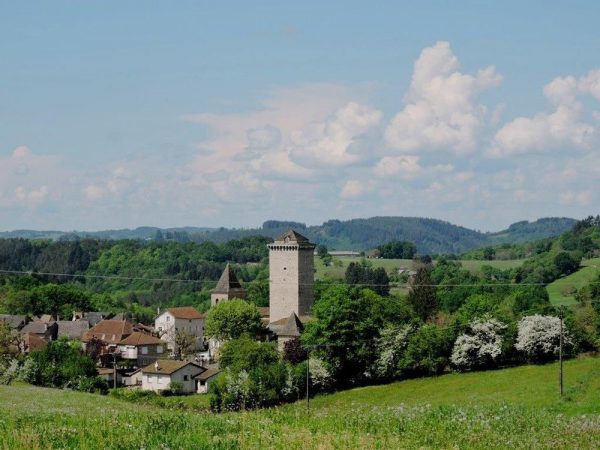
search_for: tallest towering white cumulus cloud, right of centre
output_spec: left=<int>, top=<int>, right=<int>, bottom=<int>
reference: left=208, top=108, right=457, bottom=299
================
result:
left=385, top=42, right=502, bottom=154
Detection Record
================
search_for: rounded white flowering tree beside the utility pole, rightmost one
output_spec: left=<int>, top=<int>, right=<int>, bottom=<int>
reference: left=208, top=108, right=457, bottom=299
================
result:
left=515, top=314, right=572, bottom=361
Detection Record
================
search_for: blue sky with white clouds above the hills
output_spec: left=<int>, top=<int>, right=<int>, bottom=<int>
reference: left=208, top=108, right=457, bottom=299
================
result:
left=0, top=0, right=600, bottom=231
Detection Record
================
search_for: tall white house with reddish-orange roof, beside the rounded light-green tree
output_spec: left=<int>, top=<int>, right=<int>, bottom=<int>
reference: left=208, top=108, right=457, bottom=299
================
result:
left=154, top=306, right=204, bottom=352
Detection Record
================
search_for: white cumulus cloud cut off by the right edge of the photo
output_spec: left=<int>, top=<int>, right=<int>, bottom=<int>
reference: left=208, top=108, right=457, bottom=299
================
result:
left=487, top=71, right=600, bottom=156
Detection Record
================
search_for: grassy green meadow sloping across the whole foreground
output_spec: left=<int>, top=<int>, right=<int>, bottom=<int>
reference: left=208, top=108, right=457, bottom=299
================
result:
left=0, top=357, right=600, bottom=450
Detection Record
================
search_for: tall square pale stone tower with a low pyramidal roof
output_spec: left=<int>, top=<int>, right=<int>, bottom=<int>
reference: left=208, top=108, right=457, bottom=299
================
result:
left=268, top=230, right=315, bottom=322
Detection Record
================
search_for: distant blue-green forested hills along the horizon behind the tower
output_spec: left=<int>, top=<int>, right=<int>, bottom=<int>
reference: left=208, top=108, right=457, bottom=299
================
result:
left=0, top=217, right=576, bottom=254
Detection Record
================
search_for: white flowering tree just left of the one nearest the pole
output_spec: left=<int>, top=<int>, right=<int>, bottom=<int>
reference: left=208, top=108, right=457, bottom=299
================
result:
left=450, top=319, right=506, bottom=370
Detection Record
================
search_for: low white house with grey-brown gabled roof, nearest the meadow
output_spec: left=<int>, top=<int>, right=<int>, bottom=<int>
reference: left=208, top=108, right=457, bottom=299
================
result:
left=142, top=359, right=207, bottom=393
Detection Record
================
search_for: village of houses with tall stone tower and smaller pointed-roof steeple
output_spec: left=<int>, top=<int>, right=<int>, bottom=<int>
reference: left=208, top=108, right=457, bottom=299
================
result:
left=0, top=230, right=315, bottom=394
